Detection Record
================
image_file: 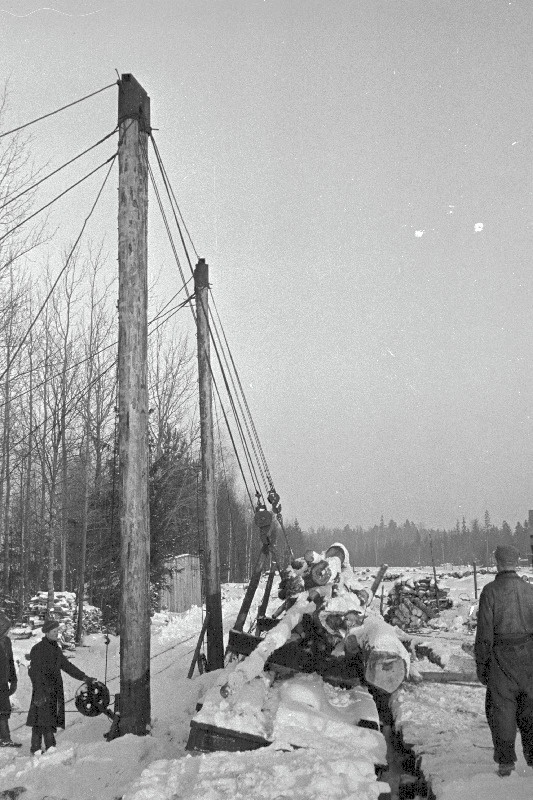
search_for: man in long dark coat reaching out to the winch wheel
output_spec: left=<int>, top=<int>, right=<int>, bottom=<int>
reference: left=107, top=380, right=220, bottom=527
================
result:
left=26, top=620, right=95, bottom=753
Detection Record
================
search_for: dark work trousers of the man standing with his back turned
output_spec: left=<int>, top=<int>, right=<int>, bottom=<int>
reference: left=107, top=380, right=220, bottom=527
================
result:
left=485, top=640, right=533, bottom=766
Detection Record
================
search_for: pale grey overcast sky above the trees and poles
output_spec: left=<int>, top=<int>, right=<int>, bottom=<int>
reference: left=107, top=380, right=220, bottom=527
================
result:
left=0, top=0, right=533, bottom=527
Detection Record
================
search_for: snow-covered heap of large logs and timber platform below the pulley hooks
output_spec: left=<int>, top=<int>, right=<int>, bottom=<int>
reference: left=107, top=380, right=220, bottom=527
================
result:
left=187, top=512, right=410, bottom=766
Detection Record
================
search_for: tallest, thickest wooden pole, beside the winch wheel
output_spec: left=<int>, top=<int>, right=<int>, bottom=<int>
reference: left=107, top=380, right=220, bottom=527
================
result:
left=118, top=74, right=150, bottom=736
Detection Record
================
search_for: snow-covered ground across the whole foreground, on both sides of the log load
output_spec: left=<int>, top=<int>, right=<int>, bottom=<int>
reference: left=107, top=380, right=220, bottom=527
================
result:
left=0, top=571, right=533, bottom=800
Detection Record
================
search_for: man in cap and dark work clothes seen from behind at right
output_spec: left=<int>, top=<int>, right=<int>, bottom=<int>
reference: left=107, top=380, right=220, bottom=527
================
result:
left=474, top=545, right=533, bottom=777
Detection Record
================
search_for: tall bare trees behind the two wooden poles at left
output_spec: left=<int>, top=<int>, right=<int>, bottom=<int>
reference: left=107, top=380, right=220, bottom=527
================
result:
left=0, top=108, right=257, bottom=622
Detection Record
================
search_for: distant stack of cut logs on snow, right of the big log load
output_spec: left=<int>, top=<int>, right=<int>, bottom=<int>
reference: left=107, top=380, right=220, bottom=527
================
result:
left=384, top=577, right=452, bottom=630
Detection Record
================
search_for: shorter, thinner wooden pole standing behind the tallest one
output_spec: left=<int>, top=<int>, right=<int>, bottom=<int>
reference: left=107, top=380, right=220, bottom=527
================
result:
left=194, top=258, right=224, bottom=670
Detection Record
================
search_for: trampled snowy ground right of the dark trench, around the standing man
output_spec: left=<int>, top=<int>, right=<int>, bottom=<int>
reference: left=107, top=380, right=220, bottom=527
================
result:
left=391, top=569, right=533, bottom=800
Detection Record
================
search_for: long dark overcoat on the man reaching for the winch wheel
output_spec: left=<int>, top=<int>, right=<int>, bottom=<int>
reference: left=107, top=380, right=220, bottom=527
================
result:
left=26, top=636, right=87, bottom=731
